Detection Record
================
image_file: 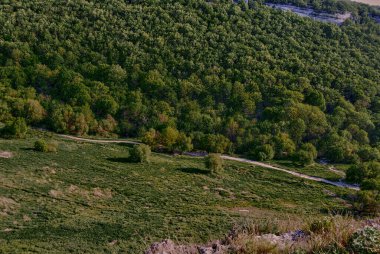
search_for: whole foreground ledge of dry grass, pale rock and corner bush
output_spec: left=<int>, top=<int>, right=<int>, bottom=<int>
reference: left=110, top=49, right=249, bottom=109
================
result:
left=146, top=216, right=380, bottom=254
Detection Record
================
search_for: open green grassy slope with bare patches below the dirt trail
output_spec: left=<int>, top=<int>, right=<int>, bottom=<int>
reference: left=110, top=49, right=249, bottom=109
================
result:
left=0, top=135, right=356, bottom=253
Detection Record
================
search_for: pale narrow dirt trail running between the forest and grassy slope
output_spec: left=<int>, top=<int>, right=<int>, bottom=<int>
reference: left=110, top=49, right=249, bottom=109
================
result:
left=58, top=135, right=360, bottom=190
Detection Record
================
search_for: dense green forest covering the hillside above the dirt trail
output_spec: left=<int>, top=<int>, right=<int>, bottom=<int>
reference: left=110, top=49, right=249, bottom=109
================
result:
left=0, top=0, right=380, bottom=162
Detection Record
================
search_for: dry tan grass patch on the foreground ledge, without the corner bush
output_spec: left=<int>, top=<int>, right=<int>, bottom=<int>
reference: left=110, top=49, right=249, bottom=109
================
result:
left=224, top=216, right=380, bottom=254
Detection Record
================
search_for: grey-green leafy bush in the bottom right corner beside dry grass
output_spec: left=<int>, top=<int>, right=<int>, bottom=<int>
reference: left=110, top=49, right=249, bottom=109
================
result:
left=348, top=227, right=380, bottom=254
